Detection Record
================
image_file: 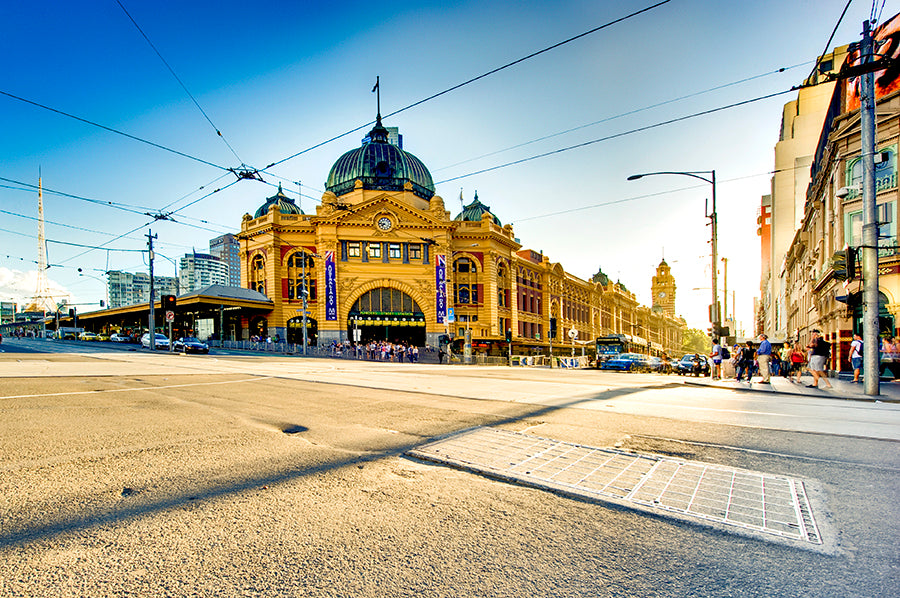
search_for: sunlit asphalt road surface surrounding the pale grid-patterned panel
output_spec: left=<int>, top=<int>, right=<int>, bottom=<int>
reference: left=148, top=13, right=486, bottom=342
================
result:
left=0, top=339, right=900, bottom=597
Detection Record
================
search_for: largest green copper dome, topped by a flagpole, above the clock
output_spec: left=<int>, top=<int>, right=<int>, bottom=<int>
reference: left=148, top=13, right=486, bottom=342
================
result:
left=325, top=115, right=434, bottom=199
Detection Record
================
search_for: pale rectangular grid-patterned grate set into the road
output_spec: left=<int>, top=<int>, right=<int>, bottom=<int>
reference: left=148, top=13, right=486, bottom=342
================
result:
left=407, top=428, right=822, bottom=544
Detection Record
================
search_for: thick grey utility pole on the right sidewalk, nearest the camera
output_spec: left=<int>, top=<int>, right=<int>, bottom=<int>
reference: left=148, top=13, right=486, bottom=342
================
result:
left=859, top=21, right=880, bottom=396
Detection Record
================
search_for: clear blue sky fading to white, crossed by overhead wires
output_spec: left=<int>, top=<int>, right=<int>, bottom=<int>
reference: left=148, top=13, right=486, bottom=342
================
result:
left=0, top=0, right=888, bottom=328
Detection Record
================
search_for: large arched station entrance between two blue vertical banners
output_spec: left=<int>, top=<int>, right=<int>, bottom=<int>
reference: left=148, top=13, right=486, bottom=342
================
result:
left=347, top=287, right=425, bottom=346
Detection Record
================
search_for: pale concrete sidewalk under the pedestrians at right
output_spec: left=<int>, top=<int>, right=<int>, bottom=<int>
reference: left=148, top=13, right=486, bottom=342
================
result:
left=685, top=374, right=900, bottom=403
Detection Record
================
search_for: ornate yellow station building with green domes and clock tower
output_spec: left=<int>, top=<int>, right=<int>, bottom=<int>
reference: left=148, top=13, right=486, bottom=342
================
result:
left=237, top=115, right=685, bottom=355
